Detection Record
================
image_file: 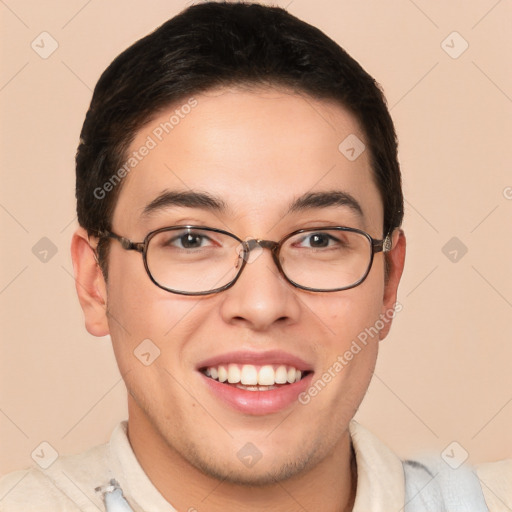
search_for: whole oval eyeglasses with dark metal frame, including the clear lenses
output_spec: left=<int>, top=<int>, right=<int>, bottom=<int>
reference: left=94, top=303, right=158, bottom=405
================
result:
left=99, top=225, right=392, bottom=295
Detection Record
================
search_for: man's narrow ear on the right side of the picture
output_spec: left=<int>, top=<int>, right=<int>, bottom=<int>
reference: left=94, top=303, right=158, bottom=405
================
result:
left=379, top=228, right=405, bottom=340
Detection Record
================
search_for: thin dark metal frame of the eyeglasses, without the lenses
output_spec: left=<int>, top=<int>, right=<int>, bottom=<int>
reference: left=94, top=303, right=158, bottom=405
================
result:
left=98, top=225, right=392, bottom=295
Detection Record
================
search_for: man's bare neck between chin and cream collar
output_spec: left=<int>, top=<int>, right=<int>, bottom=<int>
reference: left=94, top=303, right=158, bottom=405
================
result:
left=128, top=403, right=357, bottom=512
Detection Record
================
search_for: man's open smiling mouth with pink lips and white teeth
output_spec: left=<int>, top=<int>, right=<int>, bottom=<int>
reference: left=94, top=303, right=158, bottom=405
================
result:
left=197, top=351, right=314, bottom=415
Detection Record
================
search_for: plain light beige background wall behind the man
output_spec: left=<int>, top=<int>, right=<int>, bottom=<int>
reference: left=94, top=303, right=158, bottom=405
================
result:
left=0, top=0, right=512, bottom=473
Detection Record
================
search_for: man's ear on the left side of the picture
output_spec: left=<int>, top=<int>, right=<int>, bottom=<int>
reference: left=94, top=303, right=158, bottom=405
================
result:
left=71, top=227, right=110, bottom=336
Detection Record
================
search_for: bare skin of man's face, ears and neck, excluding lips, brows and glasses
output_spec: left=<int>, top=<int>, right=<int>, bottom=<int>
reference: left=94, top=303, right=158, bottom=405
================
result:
left=72, top=88, right=405, bottom=512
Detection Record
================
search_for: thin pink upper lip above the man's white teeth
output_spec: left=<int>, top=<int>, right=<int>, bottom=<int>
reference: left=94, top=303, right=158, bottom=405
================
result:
left=197, top=350, right=312, bottom=372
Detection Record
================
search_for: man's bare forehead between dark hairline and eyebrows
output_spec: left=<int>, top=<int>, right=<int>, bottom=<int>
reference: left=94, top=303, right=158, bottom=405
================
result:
left=113, top=89, right=382, bottom=234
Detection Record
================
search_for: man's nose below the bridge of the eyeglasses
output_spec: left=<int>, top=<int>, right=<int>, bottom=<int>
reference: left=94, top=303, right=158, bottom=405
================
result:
left=221, top=244, right=300, bottom=331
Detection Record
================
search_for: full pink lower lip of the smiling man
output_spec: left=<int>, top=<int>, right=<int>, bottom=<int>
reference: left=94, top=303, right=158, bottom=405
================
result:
left=201, top=373, right=313, bottom=415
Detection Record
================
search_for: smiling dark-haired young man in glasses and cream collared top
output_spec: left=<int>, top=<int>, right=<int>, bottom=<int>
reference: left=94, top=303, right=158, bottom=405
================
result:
left=1, top=3, right=512, bottom=512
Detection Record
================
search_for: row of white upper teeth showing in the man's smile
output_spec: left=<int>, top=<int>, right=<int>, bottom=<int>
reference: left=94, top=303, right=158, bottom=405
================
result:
left=205, top=364, right=302, bottom=386
